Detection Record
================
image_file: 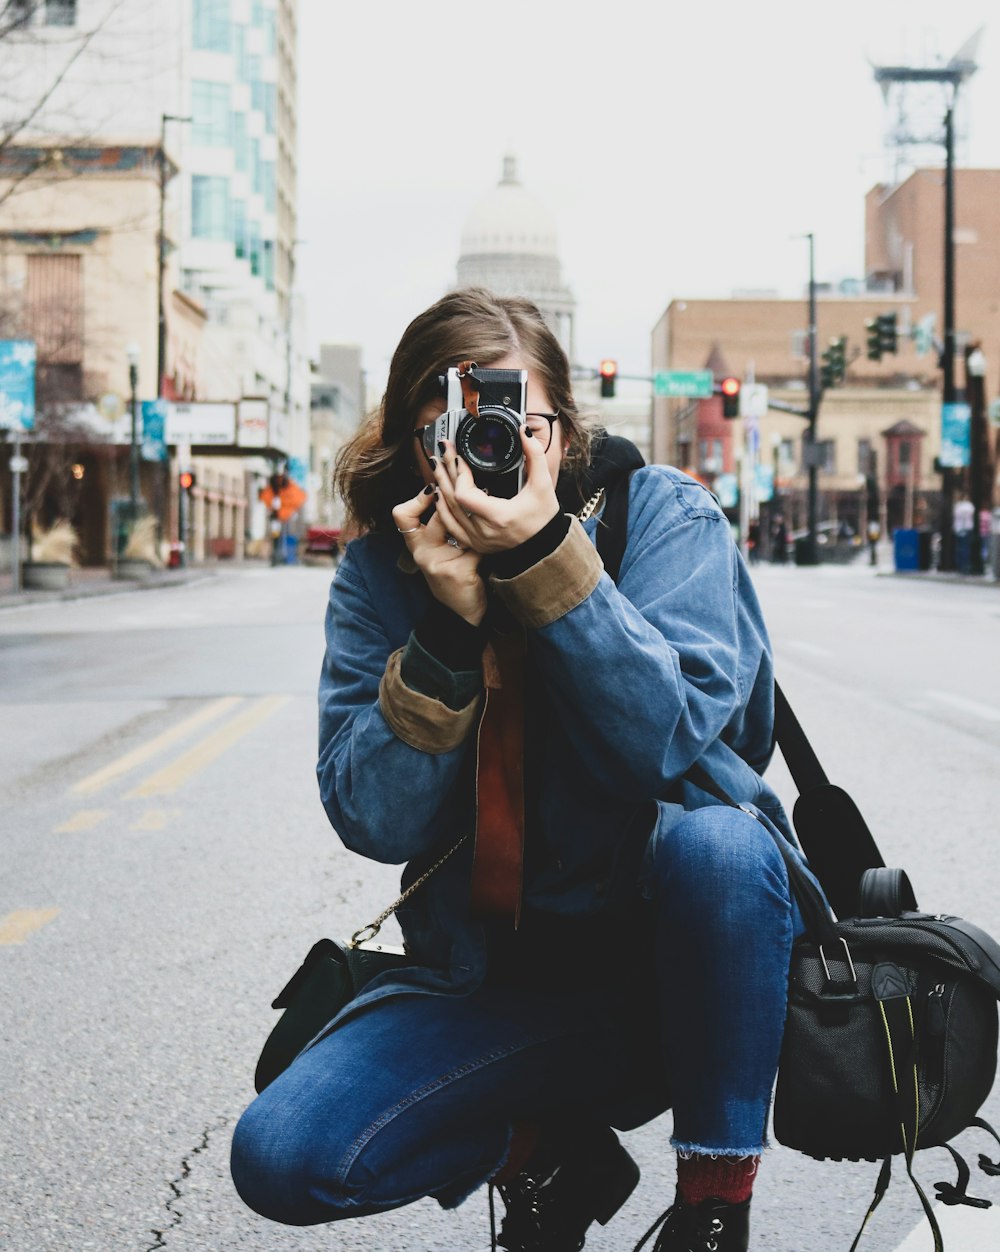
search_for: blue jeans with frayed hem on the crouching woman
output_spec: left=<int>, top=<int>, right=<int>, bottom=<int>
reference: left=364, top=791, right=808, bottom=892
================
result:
left=232, top=806, right=801, bottom=1226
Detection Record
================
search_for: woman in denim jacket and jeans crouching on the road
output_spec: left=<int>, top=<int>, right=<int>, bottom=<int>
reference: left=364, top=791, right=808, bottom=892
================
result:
left=233, top=289, right=821, bottom=1252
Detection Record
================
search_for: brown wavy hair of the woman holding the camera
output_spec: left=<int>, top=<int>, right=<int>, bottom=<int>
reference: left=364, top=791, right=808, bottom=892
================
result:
left=334, top=287, right=589, bottom=535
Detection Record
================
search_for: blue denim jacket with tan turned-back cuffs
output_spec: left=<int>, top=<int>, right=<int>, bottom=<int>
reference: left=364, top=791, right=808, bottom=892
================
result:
left=318, top=466, right=787, bottom=1017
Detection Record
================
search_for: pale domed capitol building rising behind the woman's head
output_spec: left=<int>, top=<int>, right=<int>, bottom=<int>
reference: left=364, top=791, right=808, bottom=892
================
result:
left=456, top=157, right=576, bottom=361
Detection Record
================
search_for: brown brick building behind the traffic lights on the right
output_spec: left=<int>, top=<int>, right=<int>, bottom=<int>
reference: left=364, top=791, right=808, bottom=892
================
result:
left=652, top=169, right=1000, bottom=540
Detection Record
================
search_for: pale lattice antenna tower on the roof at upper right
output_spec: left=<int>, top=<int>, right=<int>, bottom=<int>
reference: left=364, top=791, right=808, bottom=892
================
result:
left=872, top=26, right=984, bottom=187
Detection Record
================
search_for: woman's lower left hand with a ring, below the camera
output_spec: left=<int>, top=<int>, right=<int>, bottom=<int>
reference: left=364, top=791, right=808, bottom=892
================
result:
left=392, top=485, right=486, bottom=626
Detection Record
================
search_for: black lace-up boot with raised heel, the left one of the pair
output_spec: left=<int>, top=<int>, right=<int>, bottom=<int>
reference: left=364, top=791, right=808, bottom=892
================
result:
left=497, top=1127, right=638, bottom=1252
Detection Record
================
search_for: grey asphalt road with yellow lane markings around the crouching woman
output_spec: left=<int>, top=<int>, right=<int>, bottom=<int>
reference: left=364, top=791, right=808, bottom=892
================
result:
left=0, top=567, right=1000, bottom=1252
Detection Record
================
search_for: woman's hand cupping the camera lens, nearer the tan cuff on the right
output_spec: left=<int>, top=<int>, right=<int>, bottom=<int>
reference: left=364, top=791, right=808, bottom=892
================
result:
left=434, top=426, right=559, bottom=553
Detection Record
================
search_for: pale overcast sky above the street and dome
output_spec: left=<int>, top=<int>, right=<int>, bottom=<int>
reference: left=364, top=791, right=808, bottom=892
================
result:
left=298, top=0, right=1000, bottom=382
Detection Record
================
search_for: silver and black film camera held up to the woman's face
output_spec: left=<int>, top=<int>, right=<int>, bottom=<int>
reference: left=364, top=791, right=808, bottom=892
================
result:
left=421, top=366, right=528, bottom=500
